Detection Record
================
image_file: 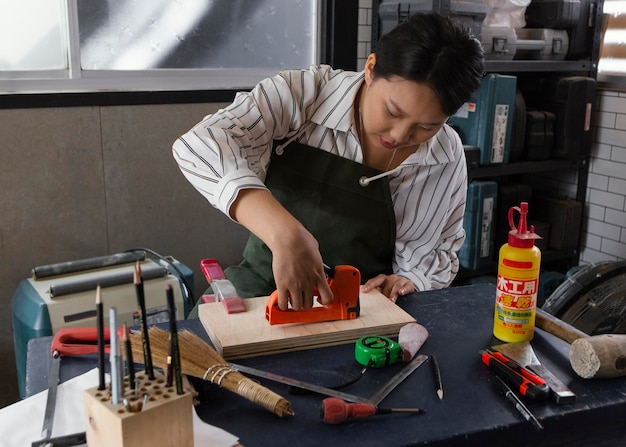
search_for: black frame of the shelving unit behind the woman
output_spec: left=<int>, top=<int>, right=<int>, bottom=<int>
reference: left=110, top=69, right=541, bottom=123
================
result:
left=372, top=0, right=604, bottom=283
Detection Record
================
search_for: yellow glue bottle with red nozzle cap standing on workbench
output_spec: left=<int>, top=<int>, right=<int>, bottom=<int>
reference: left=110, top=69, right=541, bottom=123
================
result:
left=493, top=202, right=541, bottom=343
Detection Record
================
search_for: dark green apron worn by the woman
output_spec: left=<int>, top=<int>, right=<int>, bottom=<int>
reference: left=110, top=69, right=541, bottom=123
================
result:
left=225, top=142, right=396, bottom=298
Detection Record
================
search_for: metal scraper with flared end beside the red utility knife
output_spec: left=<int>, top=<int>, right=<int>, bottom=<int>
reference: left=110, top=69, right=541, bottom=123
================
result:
left=492, top=341, right=576, bottom=405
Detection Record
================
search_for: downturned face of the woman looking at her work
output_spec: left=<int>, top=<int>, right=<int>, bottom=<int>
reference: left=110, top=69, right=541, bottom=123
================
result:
left=360, top=54, right=448, bottom=158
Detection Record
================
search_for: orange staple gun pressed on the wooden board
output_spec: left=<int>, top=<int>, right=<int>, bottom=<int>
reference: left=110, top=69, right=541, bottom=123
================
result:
left=265, top=265, right=361, bottom=324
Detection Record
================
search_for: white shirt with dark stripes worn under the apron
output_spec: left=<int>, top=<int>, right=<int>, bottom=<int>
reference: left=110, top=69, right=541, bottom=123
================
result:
left=173, top=65, right=467, bottom=290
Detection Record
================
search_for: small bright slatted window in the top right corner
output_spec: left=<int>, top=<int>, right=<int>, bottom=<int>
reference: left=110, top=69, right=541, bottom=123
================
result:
left=598, top=0, right=626, bottom=86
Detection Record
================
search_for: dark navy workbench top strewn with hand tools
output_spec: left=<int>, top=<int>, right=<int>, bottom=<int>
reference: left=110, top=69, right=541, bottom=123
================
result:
left=26, top=284, right=626, bottom=447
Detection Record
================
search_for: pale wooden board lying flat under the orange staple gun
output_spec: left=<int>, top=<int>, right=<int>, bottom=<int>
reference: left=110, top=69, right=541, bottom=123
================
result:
left=198, top=291, right=415, bottom=360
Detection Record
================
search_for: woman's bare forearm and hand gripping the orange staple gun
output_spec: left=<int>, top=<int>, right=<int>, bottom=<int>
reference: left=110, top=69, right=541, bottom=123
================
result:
left=230, top=189, right=333, bottom=310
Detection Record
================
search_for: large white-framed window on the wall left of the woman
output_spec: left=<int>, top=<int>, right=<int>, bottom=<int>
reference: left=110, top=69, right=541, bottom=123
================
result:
left=0, top=0, right=320, bottom=92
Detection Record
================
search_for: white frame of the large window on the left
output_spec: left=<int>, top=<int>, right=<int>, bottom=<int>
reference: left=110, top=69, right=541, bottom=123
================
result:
left=0, top=0, right=322, bottom=94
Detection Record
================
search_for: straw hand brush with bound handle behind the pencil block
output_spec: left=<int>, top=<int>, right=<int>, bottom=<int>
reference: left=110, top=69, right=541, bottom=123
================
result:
left=131, top=326, right=294, bottom=417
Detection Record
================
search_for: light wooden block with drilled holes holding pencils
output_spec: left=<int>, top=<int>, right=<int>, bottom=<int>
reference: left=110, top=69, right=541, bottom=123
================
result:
left=84, top=372, right=193, bottom=447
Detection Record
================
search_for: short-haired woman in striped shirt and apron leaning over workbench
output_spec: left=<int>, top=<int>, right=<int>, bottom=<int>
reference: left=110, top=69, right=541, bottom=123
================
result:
left=173, top=14, right=483, bottom=310
